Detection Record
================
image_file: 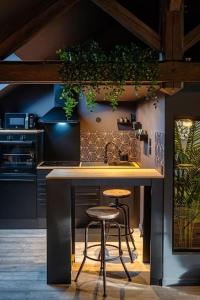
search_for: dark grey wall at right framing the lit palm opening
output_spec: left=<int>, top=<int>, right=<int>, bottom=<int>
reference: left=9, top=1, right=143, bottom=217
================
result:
left=163, top=85, right=200, bottom=285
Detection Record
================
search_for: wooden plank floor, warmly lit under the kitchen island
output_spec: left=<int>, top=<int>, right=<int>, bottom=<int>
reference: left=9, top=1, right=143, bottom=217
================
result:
left=0, top=230, right=200, bottom=300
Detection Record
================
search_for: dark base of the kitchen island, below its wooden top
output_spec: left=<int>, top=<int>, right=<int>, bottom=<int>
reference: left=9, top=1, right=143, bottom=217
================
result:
left=47, top=179, right=163, bottom=285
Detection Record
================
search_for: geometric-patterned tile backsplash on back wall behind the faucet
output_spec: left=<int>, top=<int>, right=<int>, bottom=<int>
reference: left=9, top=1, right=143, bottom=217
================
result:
left=81, top=130, right=140, bottom=162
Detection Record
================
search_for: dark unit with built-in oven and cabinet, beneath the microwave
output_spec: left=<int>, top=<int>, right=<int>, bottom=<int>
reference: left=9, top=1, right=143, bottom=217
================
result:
left=0, top=130, right=43, bottom=228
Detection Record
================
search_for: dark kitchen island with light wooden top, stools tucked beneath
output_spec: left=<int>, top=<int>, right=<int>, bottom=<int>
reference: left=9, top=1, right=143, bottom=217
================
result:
left=47, top=167, right=163, bottom=285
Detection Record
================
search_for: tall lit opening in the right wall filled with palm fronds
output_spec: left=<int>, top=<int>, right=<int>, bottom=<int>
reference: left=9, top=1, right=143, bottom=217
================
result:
left=174, top=120, right=200, bottom=250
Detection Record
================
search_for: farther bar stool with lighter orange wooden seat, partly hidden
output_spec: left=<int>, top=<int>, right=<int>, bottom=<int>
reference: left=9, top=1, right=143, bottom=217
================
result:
left=103, top=189, right=136, bottom=263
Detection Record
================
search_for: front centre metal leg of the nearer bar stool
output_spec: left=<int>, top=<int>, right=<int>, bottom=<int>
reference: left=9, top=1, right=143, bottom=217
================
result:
left=101, top=220, right=107, bottom=297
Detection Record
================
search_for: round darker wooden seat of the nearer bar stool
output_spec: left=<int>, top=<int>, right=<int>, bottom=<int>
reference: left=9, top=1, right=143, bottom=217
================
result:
left=86, top=206, right=119, bottom=220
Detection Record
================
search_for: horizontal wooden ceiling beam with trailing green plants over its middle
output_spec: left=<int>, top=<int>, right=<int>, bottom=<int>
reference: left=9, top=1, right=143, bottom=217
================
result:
left=0, top=61, right=200, bottom=84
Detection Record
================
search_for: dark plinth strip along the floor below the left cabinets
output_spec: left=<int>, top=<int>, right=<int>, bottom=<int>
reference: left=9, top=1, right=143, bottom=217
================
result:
left=0, top=218, right=46, bottom=229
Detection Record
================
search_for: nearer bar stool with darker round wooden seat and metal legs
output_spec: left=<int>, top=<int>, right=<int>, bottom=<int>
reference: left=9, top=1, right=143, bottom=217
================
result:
left=75, top=206, right=131, bottom=297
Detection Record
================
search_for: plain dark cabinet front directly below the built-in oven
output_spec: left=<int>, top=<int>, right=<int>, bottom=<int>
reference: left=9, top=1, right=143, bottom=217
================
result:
left=0, top=174, right=36, bottom=219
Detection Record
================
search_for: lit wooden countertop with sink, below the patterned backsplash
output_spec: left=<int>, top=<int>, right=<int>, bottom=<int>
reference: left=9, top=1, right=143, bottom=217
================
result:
left=80, top=161, right=139, bottom=168
